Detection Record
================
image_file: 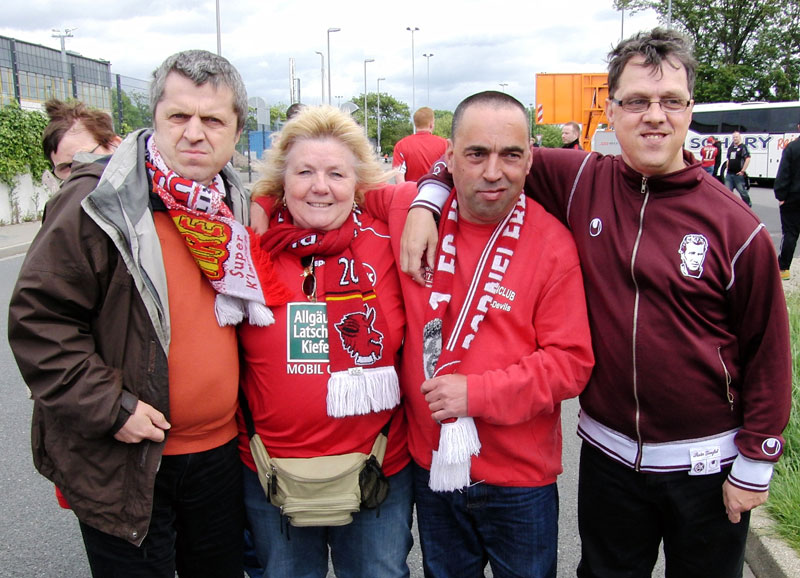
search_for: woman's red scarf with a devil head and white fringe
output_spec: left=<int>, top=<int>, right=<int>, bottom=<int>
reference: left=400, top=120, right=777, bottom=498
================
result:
left=261, top=207, right=400, bottom=417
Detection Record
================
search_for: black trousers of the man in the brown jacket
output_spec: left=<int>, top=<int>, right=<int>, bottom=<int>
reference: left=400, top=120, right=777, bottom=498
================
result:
left=80, top=438, right=244, bottom=578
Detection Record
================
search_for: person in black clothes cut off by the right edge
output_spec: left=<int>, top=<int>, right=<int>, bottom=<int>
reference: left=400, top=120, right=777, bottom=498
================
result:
left=775, top=124, right=800, bottom=281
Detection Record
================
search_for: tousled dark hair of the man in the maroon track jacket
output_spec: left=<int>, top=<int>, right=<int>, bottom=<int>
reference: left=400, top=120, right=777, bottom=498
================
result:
left=608, top=28, right=697, bottom=98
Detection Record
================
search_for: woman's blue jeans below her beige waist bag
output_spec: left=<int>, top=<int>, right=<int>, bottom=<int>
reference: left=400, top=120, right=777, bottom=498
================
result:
left=244, top=465, right=413, bottom=578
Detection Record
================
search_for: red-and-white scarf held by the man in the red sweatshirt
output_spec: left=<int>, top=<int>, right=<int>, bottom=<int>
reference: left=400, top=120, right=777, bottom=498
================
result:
left=423, top=191, right=526, bottom=492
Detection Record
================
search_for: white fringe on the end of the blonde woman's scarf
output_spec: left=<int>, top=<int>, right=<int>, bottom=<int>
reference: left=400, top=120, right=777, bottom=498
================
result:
left=327, top=367, right=400, bottom=417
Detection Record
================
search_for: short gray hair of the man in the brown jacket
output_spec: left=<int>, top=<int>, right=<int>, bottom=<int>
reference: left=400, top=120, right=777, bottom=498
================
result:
left=150, top=50, right=248, bottom=130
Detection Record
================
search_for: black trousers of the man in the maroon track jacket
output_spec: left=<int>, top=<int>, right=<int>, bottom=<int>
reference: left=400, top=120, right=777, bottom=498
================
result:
left=578, top=442, right=750, bottom=578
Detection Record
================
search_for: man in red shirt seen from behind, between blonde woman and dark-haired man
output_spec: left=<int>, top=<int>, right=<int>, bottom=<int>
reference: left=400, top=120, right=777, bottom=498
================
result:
left=392, top=106, right=447, bottom=183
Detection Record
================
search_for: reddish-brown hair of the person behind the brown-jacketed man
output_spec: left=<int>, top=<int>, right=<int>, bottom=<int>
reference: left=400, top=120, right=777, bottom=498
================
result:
left=42, top=98, right=117, bottom=164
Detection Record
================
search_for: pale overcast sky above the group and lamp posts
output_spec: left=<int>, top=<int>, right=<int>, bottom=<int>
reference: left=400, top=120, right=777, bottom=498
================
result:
left=0, top=0, right=658, bottom=110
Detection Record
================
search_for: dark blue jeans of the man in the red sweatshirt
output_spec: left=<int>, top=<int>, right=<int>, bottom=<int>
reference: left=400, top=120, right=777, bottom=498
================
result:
left=414, top=464, right=558, bottom=578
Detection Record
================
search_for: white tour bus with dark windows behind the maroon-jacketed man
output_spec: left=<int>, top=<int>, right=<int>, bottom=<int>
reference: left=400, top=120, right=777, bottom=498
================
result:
left=592, top=101, right=800, bottom=180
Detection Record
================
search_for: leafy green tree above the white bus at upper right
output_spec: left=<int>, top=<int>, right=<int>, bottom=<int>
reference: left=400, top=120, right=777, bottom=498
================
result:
left=614, top=0, right=800, bottom=102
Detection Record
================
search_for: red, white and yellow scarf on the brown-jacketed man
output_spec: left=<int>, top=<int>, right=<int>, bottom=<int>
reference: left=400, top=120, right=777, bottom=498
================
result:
left=145, top=136, right=289, bottom=326
